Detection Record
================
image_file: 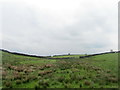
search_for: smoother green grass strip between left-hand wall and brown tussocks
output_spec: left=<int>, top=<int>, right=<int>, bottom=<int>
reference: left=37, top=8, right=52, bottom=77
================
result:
left=2, top=52, right=56, bottom=65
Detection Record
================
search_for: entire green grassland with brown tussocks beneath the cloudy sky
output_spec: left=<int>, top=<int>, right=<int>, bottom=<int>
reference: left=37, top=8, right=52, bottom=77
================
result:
left=1, top=51, right=118, bottom=88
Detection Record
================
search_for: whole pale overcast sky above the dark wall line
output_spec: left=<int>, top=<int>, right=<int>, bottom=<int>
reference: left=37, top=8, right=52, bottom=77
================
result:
left=0, top=0, right=118, bottom=55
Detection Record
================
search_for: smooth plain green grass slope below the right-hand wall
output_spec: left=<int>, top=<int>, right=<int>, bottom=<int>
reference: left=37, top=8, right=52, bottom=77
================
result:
left=82, top=53, right=118, bottom=74
